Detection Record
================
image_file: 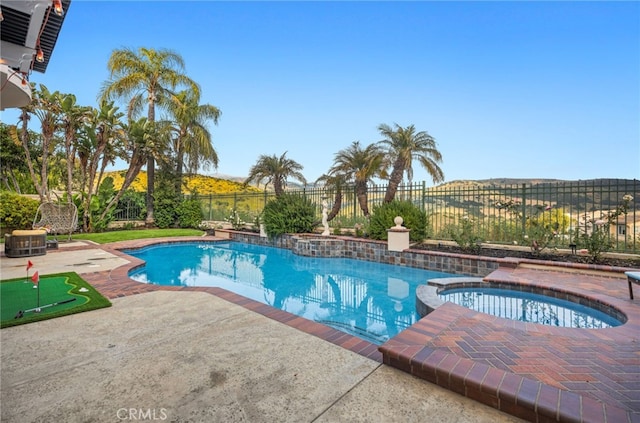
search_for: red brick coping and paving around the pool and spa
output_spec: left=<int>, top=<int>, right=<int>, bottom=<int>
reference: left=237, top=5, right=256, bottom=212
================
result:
left=38, top=237, right=640, bottom=423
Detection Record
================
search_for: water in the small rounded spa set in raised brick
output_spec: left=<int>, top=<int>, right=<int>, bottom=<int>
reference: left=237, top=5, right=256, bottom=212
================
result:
left=438, top=288, right=622, bottom=329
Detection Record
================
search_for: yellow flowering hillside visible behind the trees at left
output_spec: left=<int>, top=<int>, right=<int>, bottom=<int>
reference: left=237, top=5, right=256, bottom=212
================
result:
left=105, top=171, right=262, bottom=194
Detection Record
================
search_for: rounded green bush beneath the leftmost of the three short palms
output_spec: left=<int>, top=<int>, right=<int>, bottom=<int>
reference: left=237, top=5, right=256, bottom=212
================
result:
left=262, top=194, right=316, bottom=237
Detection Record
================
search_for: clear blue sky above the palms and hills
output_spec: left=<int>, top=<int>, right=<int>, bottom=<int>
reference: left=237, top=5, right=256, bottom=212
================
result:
left=2, top=0, right=640, bottom=185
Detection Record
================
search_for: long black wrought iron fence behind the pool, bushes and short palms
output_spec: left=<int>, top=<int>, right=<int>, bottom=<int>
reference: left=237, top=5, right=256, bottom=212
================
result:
left=174, top=179, right=640, bottom=252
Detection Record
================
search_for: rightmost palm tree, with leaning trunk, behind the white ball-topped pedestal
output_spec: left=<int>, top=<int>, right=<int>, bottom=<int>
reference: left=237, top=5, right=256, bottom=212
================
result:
left=378, top=123, right=444, bottom=203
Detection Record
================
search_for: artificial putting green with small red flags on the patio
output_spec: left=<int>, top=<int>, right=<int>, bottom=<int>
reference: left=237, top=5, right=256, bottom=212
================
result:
left=0, top=272, right=111, bottom=328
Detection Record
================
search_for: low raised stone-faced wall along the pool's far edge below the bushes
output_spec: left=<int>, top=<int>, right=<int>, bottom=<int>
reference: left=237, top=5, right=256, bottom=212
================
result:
left=216, top=230, right=499, bottom=277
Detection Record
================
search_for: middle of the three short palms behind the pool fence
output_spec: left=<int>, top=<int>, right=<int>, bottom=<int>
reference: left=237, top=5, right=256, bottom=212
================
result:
left=329, top=141, right=386, bottom=217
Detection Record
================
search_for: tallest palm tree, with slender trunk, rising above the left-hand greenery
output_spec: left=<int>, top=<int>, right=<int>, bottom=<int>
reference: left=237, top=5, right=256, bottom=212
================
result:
left=101, top=47, right=200, bottom=226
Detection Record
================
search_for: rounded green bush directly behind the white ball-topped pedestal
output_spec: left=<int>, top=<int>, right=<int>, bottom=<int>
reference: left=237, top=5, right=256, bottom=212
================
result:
left=369, top=201, right=427, bottom=242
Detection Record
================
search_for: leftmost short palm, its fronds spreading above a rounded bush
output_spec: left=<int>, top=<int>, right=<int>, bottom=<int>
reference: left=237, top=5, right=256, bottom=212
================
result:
left=244, top=151, right=307, bottom=197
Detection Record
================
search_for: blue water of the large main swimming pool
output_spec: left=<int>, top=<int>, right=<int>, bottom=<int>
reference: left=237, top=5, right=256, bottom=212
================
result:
left=126, top=242, right=455, bottom=345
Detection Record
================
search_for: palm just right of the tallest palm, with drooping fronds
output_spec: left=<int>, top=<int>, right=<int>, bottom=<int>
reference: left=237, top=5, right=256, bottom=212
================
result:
left=169, top=91, right=220, bottom=193
